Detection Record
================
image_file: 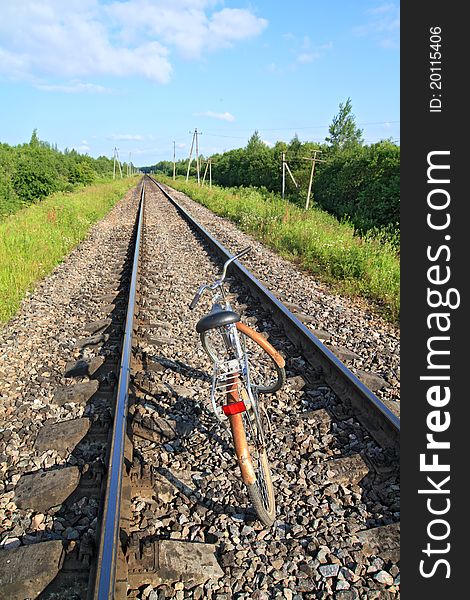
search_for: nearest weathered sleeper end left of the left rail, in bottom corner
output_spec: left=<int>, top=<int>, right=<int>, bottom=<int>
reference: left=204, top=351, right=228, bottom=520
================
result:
left=0, top=540, right=64, bottom=600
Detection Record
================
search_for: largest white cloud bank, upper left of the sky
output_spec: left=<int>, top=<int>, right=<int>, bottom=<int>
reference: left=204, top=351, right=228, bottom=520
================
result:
left=0, top=0, right=267, bottom=84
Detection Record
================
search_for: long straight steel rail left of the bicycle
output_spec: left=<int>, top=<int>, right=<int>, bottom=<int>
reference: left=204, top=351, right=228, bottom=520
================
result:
left=93, top=183, right=145, bottom=600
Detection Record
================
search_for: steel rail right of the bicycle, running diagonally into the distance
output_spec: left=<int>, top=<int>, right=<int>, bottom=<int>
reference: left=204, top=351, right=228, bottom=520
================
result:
left=149, top=177, right=400, bottom=450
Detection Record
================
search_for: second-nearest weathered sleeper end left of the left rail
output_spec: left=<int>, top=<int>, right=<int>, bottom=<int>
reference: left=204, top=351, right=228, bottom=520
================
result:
left=14, top=467, right=80, bottom=513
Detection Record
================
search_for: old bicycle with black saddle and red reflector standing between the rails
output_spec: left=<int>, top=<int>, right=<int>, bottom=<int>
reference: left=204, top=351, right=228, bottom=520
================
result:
left=189, top=246, right=286, bottom=527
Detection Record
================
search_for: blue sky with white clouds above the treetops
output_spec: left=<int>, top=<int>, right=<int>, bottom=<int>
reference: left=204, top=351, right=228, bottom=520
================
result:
left=0, top=0, right=400, bottom=166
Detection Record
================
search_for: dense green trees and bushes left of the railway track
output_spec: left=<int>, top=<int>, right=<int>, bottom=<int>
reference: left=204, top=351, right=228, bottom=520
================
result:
left=0, top=130, right=121, bottom=216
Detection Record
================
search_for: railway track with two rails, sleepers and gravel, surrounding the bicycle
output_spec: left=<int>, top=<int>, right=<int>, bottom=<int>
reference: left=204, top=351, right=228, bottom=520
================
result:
left=0, top=178, right=399, bottom=600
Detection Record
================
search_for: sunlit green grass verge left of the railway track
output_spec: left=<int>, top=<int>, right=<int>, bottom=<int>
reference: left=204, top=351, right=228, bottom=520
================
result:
left=0, top=178, right=137, bottom=322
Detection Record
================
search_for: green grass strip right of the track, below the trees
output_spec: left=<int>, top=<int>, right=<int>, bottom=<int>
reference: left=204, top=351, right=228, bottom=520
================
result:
left=158, top=176, right=400, bottom=323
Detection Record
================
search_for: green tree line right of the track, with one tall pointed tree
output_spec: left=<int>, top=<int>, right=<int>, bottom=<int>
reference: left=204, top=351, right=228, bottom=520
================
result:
left=148, top=98, right=400, bottom=236
